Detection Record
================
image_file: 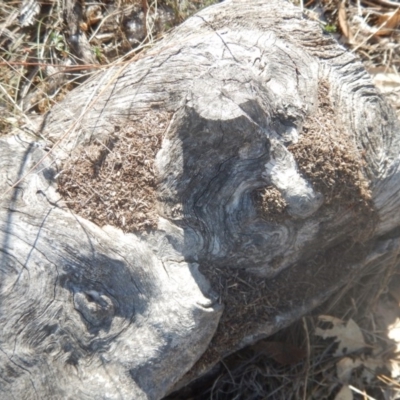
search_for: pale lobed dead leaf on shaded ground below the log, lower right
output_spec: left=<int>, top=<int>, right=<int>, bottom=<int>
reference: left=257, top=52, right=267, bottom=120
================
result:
left=315, top=315, right=366, bottom=356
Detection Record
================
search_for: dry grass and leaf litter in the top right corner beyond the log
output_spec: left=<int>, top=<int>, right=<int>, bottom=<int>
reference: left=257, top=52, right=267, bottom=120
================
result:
left=298, top=0, right=400, bottom=117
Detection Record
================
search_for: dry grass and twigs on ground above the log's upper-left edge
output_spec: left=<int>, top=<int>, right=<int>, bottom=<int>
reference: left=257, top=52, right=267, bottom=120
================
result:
left=0, top=0, right=217, bottom=134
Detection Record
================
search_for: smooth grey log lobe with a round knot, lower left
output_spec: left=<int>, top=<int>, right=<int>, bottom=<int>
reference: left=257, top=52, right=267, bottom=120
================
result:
left=0, top=137, right=221, bottom=399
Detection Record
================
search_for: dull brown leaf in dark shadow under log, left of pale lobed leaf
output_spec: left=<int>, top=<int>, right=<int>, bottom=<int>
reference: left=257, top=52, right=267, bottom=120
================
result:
left=251, top=341, right=307, bottom=365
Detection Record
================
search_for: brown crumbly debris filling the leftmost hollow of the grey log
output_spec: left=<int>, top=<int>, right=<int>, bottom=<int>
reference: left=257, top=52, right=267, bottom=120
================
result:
left=58, top=111, right=170, bottom=232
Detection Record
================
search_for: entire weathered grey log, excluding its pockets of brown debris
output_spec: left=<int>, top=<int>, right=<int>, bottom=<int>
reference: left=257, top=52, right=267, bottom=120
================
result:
left=0, top=0, right=400, bottom=399
